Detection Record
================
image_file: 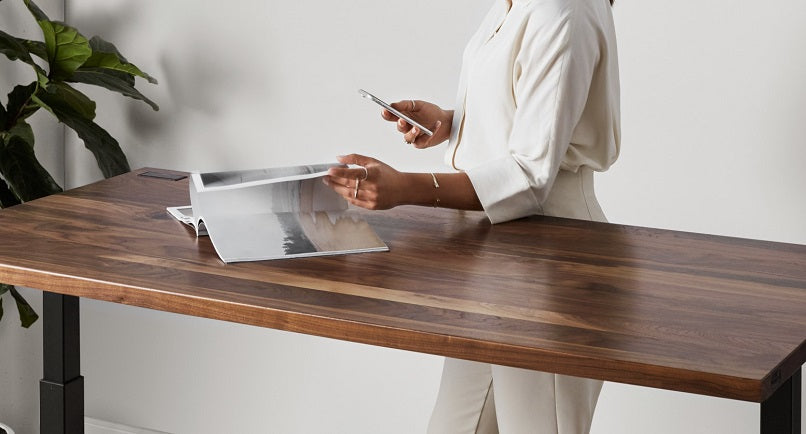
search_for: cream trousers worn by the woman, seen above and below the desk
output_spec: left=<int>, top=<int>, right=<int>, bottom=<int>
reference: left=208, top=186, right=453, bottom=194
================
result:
left=428, top=168, right=606, bottom=434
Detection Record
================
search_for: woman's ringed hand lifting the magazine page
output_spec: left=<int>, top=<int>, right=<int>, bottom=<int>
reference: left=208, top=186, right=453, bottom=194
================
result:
left=323, top=154, right=407, bottom=210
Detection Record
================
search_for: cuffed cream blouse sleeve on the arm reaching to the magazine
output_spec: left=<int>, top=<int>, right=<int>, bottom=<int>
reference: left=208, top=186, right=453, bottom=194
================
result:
left=467, top=2, right=599, bottom=223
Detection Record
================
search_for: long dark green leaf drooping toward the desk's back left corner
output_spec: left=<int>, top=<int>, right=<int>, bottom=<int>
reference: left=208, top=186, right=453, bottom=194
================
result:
left=33, top=91, right=131, bottom=178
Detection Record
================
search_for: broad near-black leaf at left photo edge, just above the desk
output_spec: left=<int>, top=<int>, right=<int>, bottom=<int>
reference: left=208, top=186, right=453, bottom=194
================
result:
left=0, top=136, right=62, bottom=202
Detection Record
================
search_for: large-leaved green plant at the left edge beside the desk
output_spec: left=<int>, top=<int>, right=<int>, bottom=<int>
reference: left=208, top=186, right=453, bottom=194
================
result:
left=0, top=0, right=159, bottom=327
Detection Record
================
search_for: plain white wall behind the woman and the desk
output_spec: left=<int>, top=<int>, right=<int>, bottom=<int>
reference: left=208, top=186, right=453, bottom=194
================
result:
left=0, top=0, right=806, bottom=434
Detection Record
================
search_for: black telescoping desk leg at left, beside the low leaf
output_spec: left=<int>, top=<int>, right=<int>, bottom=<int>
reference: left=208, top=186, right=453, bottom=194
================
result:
left=39, top=292, right=84, bottom=434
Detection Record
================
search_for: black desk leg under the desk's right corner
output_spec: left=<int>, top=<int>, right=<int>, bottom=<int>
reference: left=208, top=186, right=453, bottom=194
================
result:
left=761, top=369, right=801, bottom=434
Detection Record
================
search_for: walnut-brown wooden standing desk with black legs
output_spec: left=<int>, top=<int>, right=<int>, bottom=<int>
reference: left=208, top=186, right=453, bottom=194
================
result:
left=0, top=170, right=806, bottom=433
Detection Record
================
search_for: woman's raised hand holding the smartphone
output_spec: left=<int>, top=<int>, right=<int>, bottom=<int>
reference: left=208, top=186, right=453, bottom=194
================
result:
left=381, top=100, right=453, bottom=149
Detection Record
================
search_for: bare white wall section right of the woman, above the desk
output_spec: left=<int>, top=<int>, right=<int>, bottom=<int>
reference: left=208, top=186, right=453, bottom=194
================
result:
left=597, top=0, right=806, bottom=244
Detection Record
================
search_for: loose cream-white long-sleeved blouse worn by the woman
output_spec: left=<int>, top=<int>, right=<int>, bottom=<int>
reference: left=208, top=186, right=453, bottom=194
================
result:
left=445, top=0, right=621, bottom=223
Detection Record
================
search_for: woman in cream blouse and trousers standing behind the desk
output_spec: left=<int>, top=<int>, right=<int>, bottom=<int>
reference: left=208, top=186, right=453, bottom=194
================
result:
left=325, top=0, right=620, bottom=434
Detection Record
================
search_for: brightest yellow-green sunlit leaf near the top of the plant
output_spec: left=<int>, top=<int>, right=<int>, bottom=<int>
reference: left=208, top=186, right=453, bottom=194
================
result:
left=38, top=21, right=92, bottom=78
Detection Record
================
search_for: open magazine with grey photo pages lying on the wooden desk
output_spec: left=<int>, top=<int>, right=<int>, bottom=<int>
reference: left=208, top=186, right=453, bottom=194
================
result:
left=168, top=163, right=389, bottom=263
